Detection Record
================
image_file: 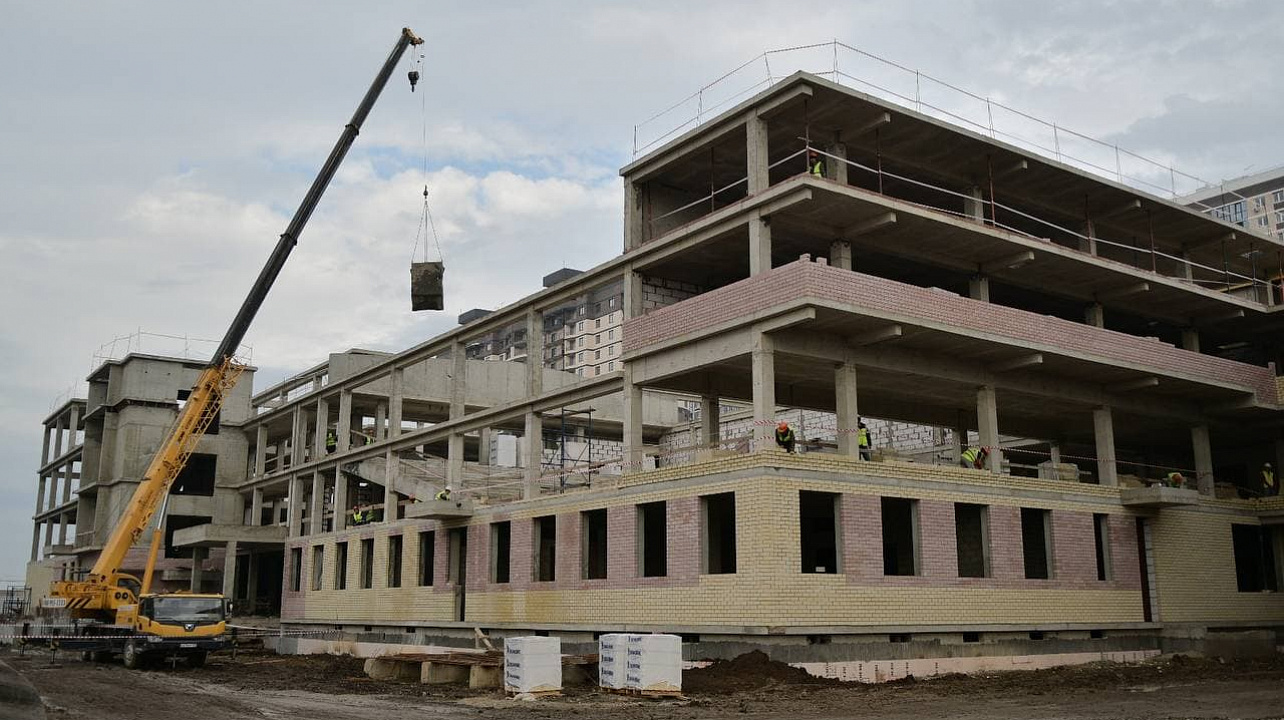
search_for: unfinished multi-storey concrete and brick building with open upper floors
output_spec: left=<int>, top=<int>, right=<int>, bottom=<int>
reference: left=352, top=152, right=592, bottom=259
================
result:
left=33, top=73, right=1284, bottom=675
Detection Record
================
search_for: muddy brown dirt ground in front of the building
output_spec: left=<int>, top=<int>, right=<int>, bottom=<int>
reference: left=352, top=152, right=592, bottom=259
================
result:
left=10, top=651, right=1284, bottom=720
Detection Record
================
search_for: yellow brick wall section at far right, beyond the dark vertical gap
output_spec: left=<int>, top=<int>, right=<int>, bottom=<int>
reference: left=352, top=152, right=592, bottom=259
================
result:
left=1150, top=503, right=1284, bottom=622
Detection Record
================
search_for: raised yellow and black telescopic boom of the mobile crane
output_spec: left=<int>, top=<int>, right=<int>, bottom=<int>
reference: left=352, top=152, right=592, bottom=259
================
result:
left=53, top=28, right=424, bottom=616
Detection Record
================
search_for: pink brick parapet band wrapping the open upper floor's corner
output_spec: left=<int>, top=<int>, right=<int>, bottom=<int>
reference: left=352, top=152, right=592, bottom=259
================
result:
left=624, top=259, right=1280, bottom=404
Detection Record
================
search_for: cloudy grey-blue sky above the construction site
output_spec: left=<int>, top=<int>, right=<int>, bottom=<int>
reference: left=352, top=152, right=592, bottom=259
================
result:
left=0, top=0, right=1284, bottom=584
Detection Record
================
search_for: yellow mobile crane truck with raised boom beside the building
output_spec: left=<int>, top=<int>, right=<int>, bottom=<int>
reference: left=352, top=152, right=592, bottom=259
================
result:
left=45, top=28, right=424, bottom=669
